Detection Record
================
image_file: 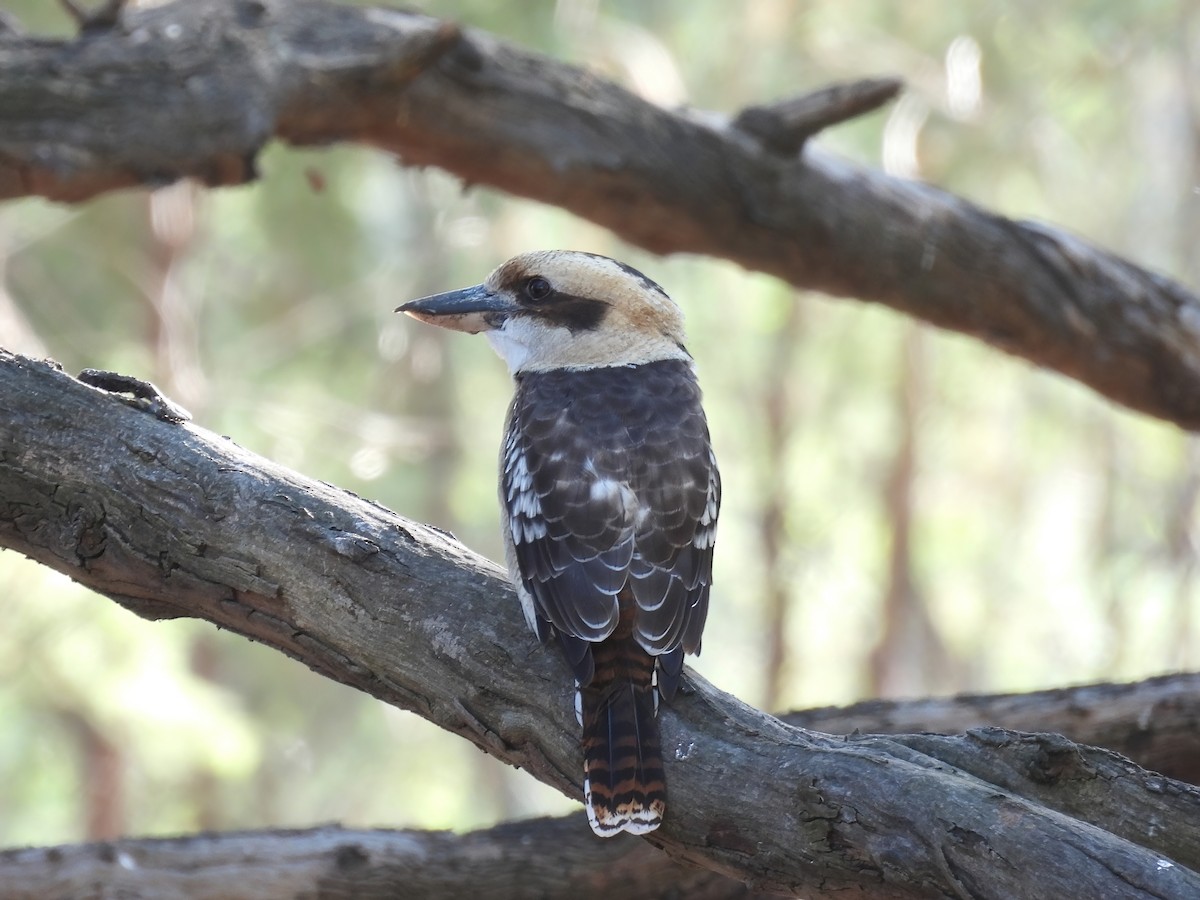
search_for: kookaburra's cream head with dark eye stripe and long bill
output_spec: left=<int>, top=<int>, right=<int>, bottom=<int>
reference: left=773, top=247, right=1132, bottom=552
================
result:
left=396, top=250, right=690, bottom=374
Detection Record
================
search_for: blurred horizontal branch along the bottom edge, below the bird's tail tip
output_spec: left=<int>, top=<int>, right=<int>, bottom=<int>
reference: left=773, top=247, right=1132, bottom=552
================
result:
left=0, top=815, right=751, bottom=900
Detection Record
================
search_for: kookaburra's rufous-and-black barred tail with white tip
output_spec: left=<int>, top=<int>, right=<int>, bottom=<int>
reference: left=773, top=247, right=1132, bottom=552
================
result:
left=580, top=638, right=667, bottom=838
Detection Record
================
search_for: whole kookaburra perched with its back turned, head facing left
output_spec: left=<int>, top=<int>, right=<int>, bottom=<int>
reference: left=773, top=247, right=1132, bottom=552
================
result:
left=396, top=250, right=721, bottom=838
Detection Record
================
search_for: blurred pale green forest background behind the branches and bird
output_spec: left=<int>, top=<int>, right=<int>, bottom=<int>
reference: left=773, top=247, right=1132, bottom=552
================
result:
left=0, top=0, right=1200, bottom=845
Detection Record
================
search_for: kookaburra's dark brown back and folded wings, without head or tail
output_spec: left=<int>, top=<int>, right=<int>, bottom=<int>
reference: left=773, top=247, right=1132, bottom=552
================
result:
left=502, top=362, right=720, bottom=680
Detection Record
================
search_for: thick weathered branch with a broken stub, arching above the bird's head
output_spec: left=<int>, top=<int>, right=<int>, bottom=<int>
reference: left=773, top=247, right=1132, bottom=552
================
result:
left=0, top=0, right=1200, bottom=428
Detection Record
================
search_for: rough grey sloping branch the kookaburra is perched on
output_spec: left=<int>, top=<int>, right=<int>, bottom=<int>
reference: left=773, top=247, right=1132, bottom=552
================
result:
left=0, top=354, right=1200, bottom=898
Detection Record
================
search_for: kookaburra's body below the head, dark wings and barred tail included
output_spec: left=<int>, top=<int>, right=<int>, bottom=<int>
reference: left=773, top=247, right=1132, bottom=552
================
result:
left=502, top=360, right=720, bottom=834
